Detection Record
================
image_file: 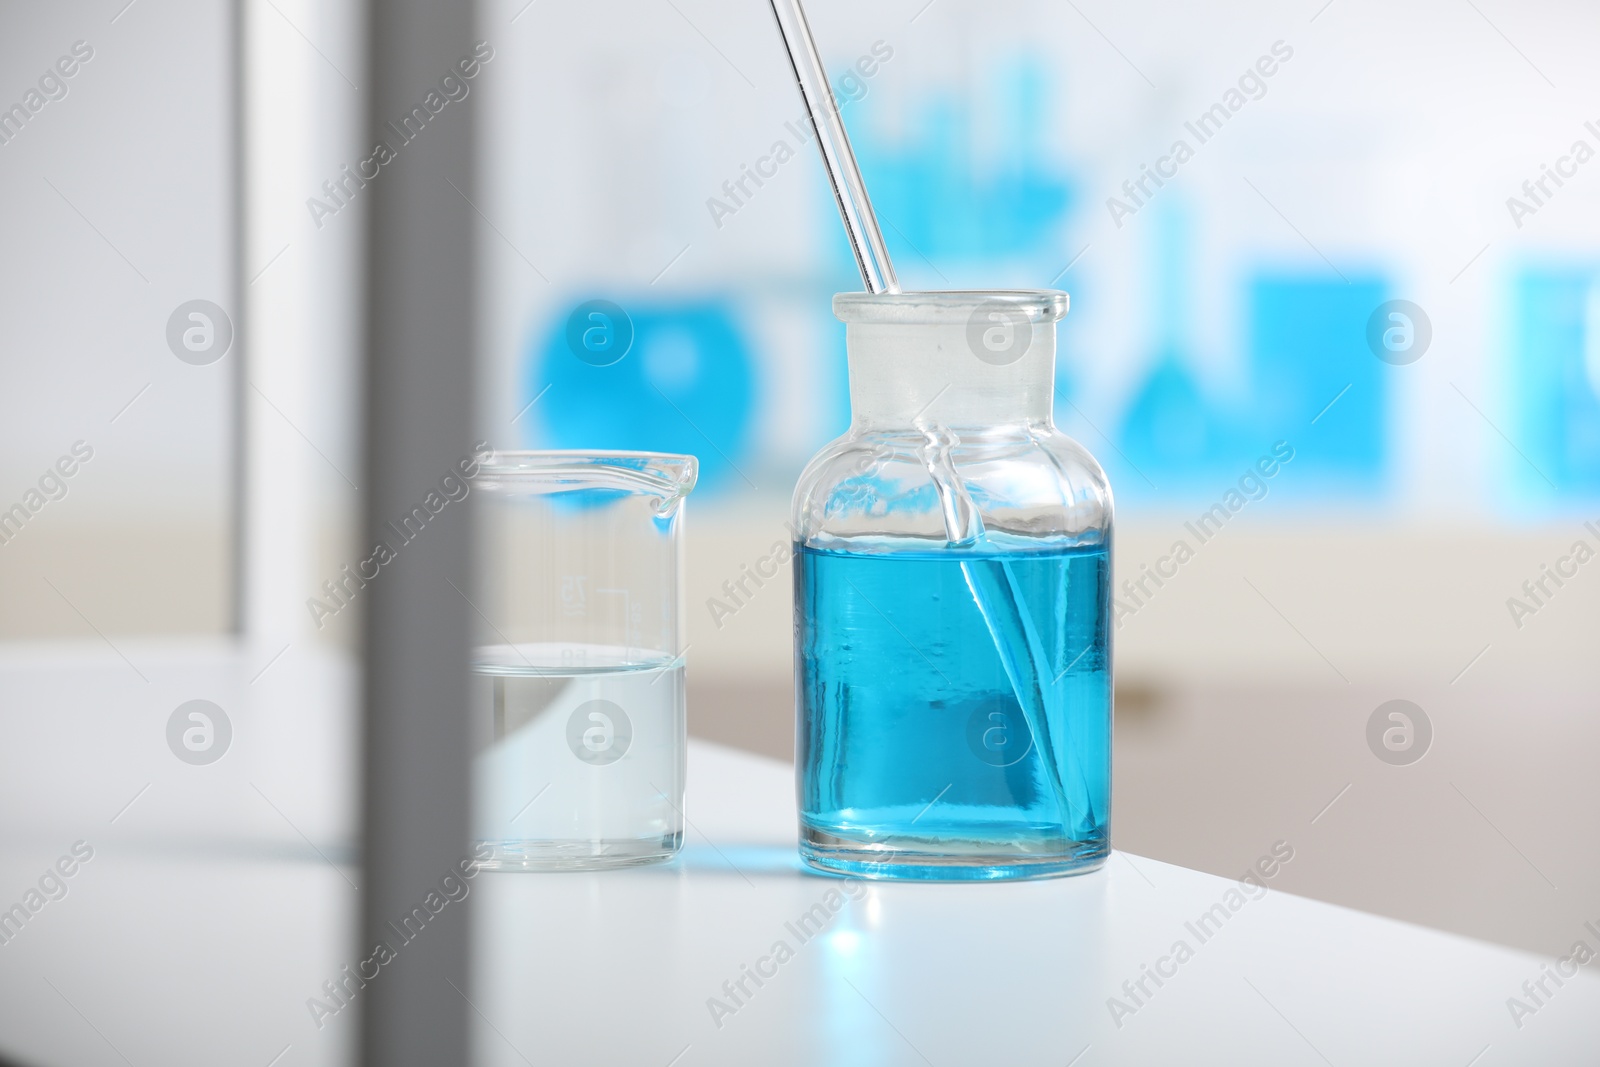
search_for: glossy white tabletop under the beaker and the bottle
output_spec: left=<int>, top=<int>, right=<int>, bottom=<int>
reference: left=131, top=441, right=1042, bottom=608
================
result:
left=0, top=648, right=1600, bottom=1067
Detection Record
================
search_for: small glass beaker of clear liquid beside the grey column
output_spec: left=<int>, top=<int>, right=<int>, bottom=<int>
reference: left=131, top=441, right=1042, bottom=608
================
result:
left=472, top=451, right=698, bottom=870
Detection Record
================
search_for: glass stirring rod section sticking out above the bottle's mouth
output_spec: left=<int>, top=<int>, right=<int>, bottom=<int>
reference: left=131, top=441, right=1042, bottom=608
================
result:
left=771, top=0, right=901, bottom=293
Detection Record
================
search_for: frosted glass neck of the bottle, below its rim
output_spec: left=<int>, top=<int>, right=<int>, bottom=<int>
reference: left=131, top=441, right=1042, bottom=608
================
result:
left=845, top=318, right=1056, bottom=432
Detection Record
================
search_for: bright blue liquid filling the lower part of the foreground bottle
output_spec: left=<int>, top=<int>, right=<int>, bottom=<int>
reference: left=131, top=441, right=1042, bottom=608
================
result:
left=795, top=542, right=1110, bottom=880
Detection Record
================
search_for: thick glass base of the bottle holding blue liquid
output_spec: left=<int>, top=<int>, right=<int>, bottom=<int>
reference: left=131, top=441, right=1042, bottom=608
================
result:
left=800, top=825, right=1110, bottom=881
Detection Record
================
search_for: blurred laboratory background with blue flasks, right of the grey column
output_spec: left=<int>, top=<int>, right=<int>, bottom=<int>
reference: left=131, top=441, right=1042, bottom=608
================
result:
left=480, top=0, right=1600, bottom=949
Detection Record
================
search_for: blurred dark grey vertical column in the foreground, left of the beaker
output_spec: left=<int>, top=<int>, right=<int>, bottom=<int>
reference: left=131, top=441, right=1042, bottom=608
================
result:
left=360, top=0, right=475, bottom=1067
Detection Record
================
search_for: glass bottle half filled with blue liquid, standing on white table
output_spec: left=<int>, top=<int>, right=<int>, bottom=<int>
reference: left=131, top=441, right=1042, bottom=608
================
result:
left=792, top=291, right=1112, bottom=880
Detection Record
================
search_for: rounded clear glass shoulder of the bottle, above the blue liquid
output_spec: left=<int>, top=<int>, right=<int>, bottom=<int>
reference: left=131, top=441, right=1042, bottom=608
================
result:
left=790, top=426, right=1112, bottom=544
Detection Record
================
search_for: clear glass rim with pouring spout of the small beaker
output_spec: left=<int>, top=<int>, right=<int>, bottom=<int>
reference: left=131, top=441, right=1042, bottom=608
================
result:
left=478, top=448, right=699, bottom=504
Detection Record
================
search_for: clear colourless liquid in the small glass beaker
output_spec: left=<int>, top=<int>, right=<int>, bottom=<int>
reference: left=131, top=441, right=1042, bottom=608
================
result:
left=472, top=643, right=685, bottom=870
